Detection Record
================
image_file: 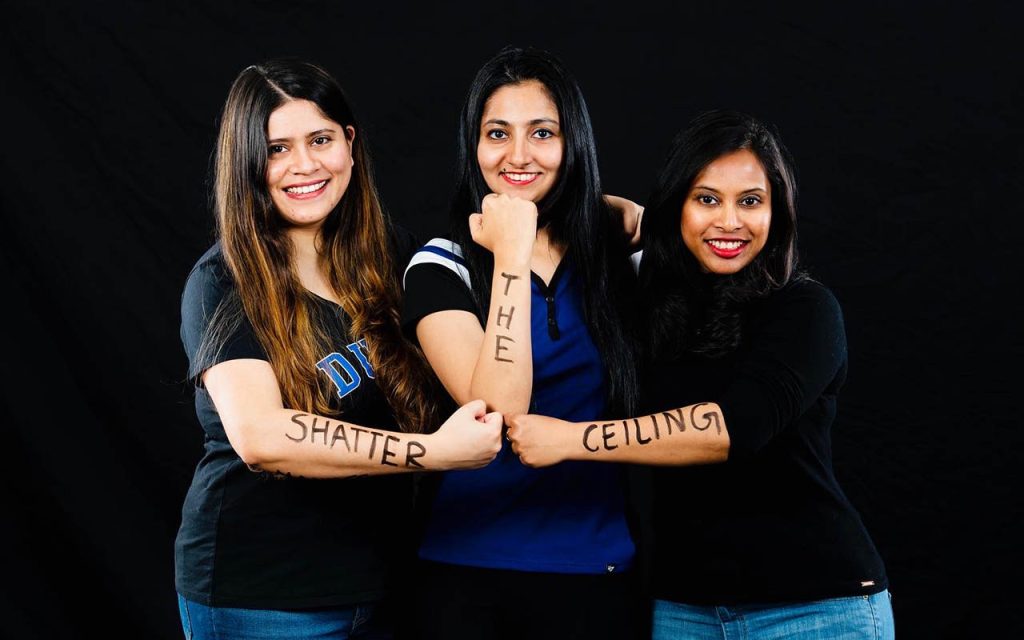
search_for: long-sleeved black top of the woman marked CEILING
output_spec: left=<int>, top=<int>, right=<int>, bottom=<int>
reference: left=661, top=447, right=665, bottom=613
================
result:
left=642, top=281, right=888, bottom=605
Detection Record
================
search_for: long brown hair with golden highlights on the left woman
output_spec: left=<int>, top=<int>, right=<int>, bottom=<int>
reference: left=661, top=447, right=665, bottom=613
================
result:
left=200, top=59, right=436, bottom=431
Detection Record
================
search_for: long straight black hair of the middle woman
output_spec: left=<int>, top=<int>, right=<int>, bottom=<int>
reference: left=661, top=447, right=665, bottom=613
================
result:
left=450, top=47, right=637, bottom=415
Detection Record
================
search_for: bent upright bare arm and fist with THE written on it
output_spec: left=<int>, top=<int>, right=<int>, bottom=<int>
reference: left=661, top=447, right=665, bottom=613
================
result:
left=416, top=194, right=537, bottom=415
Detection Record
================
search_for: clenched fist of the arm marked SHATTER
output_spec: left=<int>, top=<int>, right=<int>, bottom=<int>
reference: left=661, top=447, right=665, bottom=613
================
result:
left=431, top=400, right=503, bottom=470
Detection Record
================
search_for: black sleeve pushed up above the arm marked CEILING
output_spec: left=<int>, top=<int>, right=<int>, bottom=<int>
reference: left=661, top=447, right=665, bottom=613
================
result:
left=719, top=281, right=847, bottom=459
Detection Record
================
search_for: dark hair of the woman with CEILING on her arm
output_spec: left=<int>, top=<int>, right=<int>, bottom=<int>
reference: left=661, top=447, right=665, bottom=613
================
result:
left=639, top=111, right=805, bottom=359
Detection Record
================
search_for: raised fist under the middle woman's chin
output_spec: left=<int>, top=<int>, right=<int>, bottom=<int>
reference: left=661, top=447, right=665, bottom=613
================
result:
left=469, top=194, right=537, bottom=264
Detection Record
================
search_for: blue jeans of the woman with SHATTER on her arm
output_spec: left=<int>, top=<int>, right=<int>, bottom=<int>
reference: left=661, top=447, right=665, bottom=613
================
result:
left=178, top=594, right=391, bottom=640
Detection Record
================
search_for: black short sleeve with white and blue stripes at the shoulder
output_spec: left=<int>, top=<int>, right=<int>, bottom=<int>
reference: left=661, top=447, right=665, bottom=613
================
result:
left=401, top=239, right=479, bottom=344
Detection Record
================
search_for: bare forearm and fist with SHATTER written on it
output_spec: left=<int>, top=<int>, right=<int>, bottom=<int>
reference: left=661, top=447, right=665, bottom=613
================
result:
left=203, top=359, right=502, bottom=478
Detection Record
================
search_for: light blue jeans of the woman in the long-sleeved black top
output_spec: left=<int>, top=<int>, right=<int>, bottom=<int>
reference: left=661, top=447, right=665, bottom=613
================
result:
left=652, top=591, right=895, bottom=640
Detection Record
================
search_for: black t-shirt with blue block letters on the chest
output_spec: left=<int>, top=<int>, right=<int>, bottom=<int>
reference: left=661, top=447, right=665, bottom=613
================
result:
left=175, top=226, right=416, bottom=608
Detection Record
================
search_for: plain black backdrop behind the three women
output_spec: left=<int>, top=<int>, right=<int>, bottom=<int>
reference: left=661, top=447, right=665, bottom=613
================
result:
left=0, top=0, right=1024, bottom=638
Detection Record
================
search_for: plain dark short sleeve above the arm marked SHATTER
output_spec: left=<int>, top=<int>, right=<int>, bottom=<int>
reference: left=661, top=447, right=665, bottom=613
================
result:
left=181, top=246, right=269, bottom=384
